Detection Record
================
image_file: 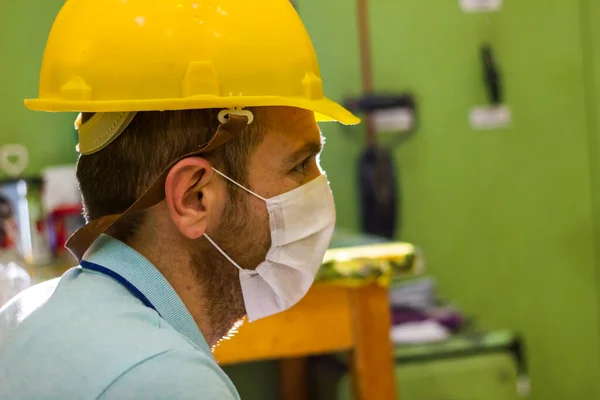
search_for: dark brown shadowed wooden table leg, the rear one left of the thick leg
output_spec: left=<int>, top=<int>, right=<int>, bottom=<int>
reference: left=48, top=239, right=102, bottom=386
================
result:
left=278, top=358, right=309, bottom=400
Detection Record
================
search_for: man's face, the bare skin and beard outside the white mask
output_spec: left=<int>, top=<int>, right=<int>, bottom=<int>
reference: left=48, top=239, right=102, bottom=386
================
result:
left=192, top=107, right=322, bottom=334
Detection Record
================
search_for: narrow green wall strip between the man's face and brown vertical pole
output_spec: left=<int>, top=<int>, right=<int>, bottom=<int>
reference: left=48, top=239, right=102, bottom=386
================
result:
left=295, top=0, right=363, bottom=231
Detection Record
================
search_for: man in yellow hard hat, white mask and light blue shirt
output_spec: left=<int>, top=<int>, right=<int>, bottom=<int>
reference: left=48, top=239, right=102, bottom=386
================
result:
left=0, top=0, right=358, bottom=399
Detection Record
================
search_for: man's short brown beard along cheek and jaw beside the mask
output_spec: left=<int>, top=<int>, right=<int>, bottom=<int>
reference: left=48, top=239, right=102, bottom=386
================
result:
left=192, top=193, right=270, bottom=343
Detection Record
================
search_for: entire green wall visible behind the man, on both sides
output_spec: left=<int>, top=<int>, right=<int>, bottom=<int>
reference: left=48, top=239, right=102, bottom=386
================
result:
left=0, top=0, right=600, bottom=400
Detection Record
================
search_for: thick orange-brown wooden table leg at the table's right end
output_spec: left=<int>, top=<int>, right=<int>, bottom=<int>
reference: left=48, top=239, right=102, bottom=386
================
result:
left=351, top=285, right=398, bottom=400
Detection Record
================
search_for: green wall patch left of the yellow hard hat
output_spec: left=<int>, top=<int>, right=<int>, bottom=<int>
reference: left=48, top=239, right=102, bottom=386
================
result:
left=0, top=0, right=77, bottom=179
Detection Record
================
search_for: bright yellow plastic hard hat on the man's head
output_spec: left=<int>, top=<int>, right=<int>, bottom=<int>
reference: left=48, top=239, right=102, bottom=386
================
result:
left=25, top=0, right=360, bottom=124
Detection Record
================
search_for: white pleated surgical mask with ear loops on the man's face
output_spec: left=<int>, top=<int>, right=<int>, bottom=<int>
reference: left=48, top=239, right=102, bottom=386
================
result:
left=204, top=168, right=335, bottom=322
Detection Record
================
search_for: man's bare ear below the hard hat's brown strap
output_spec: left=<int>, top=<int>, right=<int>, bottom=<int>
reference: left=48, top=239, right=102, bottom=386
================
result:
left=165, top=157, right=216, bottom=239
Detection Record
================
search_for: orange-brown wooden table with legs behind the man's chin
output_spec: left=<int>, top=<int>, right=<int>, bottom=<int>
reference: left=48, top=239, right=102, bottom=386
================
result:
left=215, top=284, right=397, bottom=400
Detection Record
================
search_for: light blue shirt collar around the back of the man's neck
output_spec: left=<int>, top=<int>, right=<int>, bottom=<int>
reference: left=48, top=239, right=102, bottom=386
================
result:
left=83, top=235, right=211, bottom=354
